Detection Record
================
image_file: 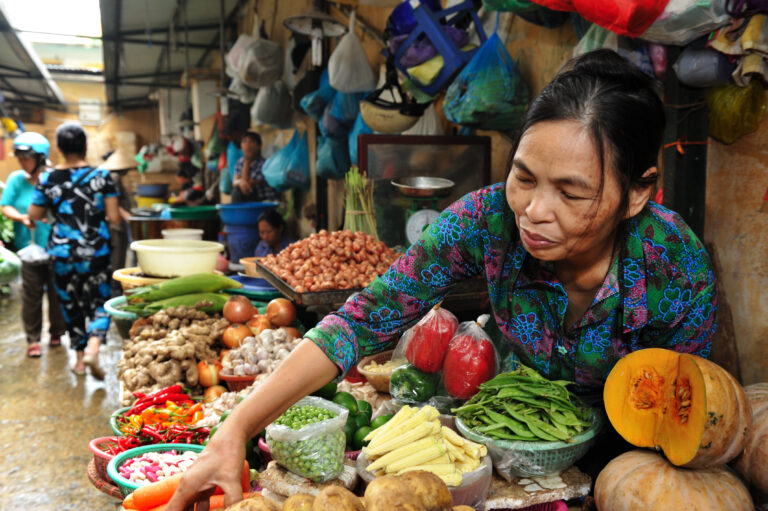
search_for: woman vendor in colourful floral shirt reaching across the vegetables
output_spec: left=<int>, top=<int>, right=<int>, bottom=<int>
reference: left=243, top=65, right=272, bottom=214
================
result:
left=166, top=50, right=717, bottom=511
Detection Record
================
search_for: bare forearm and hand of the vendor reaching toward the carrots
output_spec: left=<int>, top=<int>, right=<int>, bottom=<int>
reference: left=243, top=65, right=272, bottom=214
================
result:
left=165, top=339, right=338, bottom=511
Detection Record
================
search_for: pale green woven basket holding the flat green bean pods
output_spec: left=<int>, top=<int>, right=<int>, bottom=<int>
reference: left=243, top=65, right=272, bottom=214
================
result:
left=456, top=410, right=603, bottom=480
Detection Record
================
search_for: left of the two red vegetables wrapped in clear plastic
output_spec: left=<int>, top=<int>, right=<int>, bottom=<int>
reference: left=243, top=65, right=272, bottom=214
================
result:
left=405, top=308, right=459, bottom=373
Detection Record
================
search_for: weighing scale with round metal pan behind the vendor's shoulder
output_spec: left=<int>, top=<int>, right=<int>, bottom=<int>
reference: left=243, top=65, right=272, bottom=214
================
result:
left=391, top=176, right=455, bottom=244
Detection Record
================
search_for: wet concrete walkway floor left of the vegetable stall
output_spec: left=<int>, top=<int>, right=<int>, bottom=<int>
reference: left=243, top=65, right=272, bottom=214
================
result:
left=0, top=286, right=122, bottom=511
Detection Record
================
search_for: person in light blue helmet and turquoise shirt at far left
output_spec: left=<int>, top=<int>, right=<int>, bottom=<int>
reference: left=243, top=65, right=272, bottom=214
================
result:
left=0, top=131, right=67, bottom=358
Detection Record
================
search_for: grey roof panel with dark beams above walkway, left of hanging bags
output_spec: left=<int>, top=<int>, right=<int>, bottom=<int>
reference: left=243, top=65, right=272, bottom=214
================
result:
left=99, top=0, right=247, bottom=108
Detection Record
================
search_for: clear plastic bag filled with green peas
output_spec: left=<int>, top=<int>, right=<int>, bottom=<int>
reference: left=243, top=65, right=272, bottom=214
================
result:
left=266, top=396, right=349, bottom=483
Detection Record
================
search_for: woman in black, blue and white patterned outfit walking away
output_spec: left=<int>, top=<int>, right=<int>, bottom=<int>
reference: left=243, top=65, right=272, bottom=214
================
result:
left=29, top=123, right=120, bottom=380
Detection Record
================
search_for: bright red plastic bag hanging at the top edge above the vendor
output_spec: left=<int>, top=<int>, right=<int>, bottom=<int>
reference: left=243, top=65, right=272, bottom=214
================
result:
left=534, top=0, right=669, bottom=37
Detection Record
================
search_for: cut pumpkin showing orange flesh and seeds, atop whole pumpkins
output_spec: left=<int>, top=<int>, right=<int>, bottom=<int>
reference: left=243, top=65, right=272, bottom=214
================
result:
left=603, top=348, right=752, bottom=468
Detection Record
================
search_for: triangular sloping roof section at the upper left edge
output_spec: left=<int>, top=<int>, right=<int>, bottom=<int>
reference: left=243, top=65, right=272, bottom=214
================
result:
left=0, top=4, right=65, bottom=108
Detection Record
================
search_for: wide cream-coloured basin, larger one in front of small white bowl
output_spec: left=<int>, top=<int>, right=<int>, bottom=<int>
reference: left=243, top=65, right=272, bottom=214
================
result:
left=131, top=240, right=224, bottom=277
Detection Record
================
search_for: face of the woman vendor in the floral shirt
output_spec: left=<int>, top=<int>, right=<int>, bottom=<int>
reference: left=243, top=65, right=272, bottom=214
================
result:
left=506, top=121, right=621, bottom=264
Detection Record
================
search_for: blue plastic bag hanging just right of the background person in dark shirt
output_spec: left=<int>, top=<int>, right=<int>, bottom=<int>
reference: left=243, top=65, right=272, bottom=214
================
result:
left=261, top=130, right=310, bottom=192
